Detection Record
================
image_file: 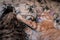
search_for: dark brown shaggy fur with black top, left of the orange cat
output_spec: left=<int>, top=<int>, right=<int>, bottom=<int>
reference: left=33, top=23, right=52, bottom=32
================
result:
left=0, top=4, right=27, bottom=40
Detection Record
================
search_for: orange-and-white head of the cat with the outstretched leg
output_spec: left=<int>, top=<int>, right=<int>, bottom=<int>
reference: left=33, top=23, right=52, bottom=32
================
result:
left=38, top=10, right=54, bottom=22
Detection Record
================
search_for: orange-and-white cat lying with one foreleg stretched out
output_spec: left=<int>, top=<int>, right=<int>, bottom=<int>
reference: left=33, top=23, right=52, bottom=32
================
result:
left=17, top=11, right=60, bottom=40
